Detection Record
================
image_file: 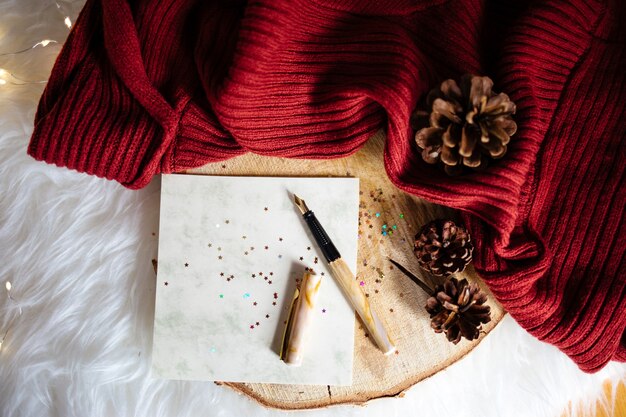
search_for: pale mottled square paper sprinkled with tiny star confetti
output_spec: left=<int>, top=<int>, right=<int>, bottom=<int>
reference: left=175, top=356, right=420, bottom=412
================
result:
left=152, top=175, right=359, bottom=385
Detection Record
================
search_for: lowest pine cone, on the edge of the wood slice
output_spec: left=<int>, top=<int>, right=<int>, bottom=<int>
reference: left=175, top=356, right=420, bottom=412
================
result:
left=426, top=278, right=491, bottom=345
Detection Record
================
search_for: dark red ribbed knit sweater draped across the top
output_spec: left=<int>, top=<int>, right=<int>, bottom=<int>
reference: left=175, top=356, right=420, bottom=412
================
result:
left=28, top=0, right=626, bottom=371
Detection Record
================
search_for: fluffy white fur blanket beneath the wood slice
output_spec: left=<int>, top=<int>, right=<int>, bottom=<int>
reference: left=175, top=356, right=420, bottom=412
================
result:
left=0, top=0, right=626, bottom=417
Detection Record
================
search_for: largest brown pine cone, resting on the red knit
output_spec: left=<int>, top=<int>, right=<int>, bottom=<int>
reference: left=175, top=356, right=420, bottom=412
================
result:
left=415, top=74, right=517, bottom=175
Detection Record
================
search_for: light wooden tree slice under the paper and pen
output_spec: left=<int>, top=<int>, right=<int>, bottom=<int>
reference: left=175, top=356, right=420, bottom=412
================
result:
left=188, top=133, right=505, bottom=409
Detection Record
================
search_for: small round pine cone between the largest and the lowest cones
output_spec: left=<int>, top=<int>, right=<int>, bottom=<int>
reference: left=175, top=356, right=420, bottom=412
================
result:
left=413, top=219, right=474, bottom=276
